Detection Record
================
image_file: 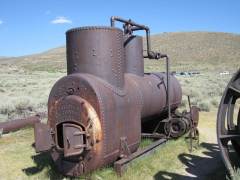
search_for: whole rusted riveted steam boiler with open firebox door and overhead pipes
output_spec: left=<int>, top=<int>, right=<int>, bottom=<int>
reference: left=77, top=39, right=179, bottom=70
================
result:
left=35, top=17, right=198, bottom=176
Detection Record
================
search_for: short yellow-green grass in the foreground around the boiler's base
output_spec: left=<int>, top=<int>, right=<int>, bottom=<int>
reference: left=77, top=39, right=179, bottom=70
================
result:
left=0, top=112, right=225, bottom=179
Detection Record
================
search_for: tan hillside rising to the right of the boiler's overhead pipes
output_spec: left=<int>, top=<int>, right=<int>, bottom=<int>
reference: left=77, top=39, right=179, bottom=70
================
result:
left=152, top=32, right=240, bottom=71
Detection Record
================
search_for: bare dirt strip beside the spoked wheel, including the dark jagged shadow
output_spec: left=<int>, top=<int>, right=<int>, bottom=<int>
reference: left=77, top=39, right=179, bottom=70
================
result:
left=155, top=111, right=228, bottom=179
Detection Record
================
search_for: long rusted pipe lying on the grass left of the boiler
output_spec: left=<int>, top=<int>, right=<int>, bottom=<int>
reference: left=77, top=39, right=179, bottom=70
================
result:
left=0, top=113, right=44, bottom=134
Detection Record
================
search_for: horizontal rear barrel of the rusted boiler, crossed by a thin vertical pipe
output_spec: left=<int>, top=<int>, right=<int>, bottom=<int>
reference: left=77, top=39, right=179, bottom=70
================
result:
left=125, top=73, right=182, bottom=122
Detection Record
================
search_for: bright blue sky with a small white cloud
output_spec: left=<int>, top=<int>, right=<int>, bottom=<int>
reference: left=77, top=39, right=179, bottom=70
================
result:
left=0, top=0, right=240, bottom=56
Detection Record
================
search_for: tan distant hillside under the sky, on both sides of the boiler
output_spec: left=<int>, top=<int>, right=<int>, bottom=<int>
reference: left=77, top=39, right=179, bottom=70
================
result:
left=0, top=32, right=240, bottom=71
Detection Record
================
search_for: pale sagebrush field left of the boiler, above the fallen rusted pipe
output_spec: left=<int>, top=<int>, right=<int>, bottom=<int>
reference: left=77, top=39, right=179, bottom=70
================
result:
left=0, top=65, right=64, bottom=121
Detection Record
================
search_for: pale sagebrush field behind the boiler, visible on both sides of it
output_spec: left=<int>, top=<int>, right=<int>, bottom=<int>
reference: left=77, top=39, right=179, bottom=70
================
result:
left=0, top=62, right=231, bottom=121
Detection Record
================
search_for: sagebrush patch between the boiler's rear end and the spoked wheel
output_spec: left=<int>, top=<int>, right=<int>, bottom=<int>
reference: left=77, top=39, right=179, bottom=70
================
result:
left=177, top=72, right=232, bottom=111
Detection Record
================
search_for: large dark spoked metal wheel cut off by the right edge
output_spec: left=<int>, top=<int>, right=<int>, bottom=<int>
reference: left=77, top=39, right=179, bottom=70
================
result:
left=217, top=69, right=240, bottom=176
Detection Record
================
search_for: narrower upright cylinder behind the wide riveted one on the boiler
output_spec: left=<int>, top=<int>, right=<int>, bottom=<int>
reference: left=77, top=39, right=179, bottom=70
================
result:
left=124, top=36, right=144, bottom=76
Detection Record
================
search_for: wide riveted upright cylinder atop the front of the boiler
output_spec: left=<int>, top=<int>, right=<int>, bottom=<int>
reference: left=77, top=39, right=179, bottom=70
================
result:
left=66, top=26, right=125, bottom=87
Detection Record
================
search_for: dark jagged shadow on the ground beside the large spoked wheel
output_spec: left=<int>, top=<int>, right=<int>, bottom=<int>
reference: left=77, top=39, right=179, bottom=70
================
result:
left=154, top=143, right=227, bottom=180
